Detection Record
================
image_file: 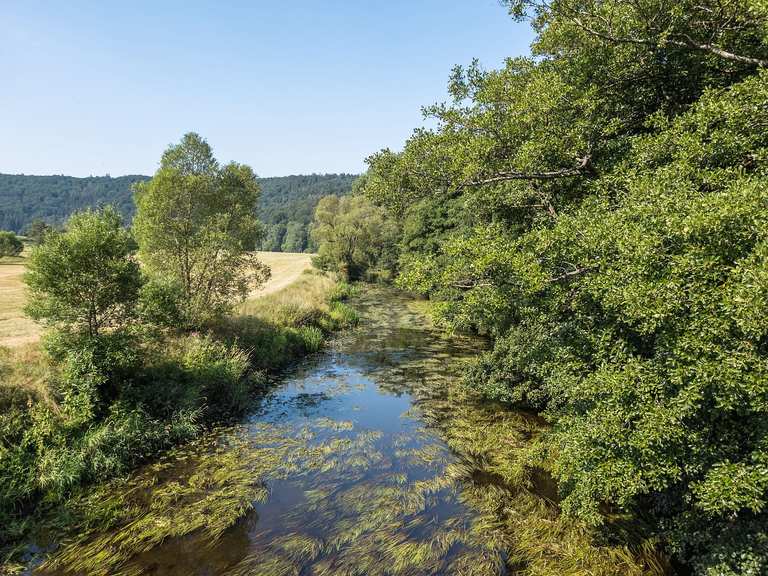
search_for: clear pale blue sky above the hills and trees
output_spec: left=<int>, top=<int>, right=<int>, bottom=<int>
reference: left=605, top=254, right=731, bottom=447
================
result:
left=0, top=0, right=533, bottom=176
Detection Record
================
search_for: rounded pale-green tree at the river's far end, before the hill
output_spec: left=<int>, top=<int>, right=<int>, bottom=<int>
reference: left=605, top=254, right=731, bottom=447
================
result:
left=312, top=195, right=398, bottom=280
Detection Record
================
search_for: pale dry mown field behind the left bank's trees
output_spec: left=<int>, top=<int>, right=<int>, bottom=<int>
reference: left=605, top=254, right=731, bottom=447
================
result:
left=0, top=252, right=312, bottom=348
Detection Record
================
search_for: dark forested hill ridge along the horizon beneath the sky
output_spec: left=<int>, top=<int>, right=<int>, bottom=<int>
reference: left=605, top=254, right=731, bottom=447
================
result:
left=0, top=174, right=357, bottom=252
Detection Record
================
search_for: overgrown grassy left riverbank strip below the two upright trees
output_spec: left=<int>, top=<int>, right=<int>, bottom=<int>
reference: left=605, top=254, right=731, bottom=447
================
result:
left=0, top=271, right=357, bottom=573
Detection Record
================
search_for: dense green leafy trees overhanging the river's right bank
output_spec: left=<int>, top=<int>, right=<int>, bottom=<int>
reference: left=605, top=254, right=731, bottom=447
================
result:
left=310, top=0, right=768, bottom=575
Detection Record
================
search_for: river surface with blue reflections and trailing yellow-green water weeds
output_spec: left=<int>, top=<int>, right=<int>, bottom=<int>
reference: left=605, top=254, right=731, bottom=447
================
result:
left=30, top=289, right=664, bottom=576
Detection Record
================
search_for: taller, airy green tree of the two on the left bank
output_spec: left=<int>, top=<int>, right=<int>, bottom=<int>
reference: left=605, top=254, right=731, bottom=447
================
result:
left=133, top=133, right=269, bottom=325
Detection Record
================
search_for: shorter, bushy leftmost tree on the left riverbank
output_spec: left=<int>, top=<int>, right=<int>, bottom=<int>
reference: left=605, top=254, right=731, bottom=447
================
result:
left=24, top=207, right=142, bottom=337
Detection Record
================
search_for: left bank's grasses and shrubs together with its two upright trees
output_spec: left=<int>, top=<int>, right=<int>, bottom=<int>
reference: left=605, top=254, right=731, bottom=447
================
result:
left=0, top=134, right=356, bottom=570
